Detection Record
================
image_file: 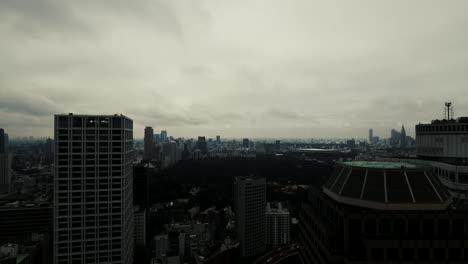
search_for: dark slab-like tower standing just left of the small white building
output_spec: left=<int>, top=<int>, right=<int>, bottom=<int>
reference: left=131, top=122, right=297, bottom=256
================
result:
left=235, top=177, right=266, bottom=257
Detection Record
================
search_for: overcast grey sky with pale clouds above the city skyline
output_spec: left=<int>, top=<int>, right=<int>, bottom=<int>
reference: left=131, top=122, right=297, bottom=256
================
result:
left=0, top=0, right=468, bottom=138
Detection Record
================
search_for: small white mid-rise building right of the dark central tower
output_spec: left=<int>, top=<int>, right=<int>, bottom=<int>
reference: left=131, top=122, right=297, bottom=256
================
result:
left=266, top=203, right=291, bottom=248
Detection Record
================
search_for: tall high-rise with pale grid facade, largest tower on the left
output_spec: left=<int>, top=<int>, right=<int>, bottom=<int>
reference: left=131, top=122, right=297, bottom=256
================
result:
left=54, top=114, right=134, bottom=264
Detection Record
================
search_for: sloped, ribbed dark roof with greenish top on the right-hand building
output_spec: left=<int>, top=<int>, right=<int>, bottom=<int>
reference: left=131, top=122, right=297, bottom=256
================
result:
left=323, top=161, right=451, bottom=210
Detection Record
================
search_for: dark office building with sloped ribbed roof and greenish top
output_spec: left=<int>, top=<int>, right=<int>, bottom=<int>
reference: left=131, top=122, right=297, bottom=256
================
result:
left=299, top=161, right=468, bottom=264
